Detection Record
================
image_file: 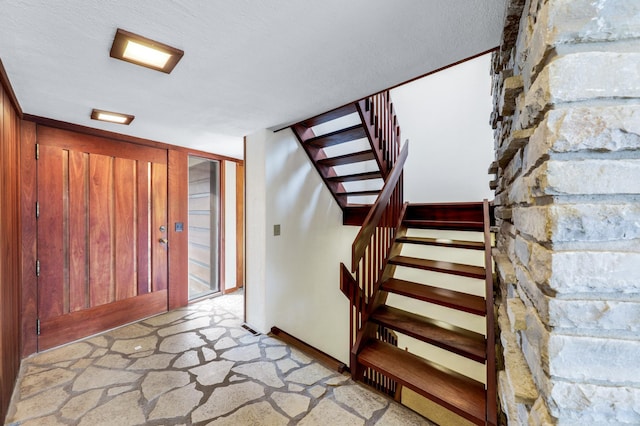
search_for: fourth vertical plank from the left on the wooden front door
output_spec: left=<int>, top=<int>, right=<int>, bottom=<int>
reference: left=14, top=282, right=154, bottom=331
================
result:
left=114, top=158, right=137, bottom=300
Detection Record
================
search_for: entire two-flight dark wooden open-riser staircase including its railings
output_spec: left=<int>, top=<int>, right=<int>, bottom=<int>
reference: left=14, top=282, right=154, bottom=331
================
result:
left=292, top=92, right=497, bottom=425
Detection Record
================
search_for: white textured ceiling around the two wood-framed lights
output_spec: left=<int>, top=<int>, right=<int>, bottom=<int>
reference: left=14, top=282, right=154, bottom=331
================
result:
left=0, top=0, right=506, bottom=158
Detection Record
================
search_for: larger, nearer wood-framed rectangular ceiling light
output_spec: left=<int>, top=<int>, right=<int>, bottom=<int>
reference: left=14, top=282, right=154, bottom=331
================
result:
left=110, top=28, right=184, bottom=74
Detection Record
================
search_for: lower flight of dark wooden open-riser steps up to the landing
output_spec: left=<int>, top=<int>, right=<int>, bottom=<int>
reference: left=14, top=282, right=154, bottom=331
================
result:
left=351, top=203, right=496, bottom=424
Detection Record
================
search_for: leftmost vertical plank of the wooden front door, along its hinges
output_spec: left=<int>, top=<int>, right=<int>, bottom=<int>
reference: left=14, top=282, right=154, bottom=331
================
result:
left=38, top=146, right=65, bottom=319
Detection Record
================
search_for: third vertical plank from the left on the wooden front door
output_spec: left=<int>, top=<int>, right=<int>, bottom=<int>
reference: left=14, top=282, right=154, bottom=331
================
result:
left=89, top=153, right=114, bottom=307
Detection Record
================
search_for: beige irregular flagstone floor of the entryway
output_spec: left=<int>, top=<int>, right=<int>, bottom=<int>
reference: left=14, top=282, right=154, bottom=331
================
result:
left=7, top=294, right=432, bottom=426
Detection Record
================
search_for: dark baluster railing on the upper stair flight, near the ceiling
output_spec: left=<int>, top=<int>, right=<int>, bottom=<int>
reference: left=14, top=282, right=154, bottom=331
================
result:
left=357, top=90, right=400, bottom=176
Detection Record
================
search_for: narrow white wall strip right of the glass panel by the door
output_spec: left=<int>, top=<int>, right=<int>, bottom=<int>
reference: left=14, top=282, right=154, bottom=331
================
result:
left=224, top=161, right=237, bottom=288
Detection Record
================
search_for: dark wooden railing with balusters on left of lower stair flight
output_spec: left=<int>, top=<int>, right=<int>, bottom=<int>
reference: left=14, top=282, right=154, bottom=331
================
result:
left=340, top=141, right=409, bottom=377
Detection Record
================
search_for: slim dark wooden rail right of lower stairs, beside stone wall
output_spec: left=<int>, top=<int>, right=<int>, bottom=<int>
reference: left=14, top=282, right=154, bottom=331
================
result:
left=482, top=199, right=498, bottom=425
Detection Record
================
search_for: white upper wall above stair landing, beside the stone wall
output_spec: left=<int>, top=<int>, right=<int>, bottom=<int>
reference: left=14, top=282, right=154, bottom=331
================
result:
left=391, top=54, right=494, bottom=203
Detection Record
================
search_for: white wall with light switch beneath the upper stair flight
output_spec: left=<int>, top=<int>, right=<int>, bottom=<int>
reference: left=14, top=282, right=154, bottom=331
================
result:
left=245, top=129, right=359, bottom=363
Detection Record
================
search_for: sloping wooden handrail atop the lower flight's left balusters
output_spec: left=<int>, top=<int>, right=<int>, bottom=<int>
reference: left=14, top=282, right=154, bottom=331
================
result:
left=351, top=141, right=409, bottom=272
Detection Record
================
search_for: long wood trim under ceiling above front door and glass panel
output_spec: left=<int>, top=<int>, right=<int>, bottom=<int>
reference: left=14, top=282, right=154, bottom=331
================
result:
left=22, top=114, right=244, bottom=163
